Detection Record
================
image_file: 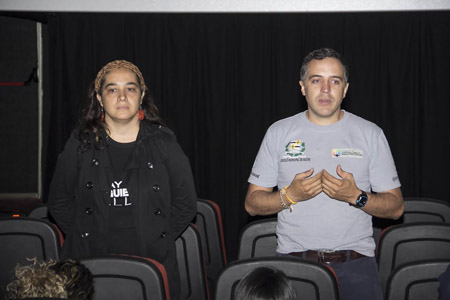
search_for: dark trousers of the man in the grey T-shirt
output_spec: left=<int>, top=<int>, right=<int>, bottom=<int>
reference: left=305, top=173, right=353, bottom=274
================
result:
left=277, top=253, right=383, bottom=300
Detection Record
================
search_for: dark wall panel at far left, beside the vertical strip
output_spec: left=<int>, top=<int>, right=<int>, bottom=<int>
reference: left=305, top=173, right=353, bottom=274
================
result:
left=0, top=16, right=39, bottom=195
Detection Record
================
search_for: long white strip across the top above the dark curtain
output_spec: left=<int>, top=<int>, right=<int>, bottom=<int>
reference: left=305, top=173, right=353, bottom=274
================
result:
left=0, top=0, right=450, bottom=13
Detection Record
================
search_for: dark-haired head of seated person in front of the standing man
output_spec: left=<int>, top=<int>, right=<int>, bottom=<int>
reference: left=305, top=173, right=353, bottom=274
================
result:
left=234, top=267, right=297, bottom=300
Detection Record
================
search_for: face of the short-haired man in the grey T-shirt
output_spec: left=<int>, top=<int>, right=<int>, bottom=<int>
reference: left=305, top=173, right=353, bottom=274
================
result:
left=300, top=57, right=348, bottom=125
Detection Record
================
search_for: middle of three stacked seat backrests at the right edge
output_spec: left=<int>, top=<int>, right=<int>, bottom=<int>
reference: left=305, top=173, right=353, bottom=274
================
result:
left=377, top=223, right=450, bottom=291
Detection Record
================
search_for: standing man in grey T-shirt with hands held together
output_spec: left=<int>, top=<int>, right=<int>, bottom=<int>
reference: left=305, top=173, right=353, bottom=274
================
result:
left=245, top=48, right=403, bottom=300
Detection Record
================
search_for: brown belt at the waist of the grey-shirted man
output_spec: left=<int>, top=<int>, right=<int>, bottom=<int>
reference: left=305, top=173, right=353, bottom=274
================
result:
left=289, top=250, right=366, bottom=264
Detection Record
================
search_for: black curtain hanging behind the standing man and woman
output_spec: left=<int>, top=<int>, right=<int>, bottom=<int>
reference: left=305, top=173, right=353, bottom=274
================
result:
left=44, top=11, right=450, bottom=259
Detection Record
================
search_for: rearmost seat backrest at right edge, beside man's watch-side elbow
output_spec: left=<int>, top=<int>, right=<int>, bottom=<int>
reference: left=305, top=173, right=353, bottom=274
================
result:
left=373, top=197, right=450, bottom=242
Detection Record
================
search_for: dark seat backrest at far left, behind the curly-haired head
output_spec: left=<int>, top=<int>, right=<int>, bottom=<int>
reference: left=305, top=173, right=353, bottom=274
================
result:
left=0, top=218, right=60, bottom=299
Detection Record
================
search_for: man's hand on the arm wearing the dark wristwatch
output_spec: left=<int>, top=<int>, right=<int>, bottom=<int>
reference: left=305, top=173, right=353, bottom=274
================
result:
left=322, top=165, right=361, bottom=204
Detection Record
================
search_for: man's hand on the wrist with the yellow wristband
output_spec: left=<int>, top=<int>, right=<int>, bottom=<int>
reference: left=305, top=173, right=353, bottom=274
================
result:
left=286, top=168, right=323, bottom=202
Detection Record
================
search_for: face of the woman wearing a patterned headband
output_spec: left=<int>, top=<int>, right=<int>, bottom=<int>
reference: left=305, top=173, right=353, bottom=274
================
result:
left=97, top=68, right=144, bottom=124
